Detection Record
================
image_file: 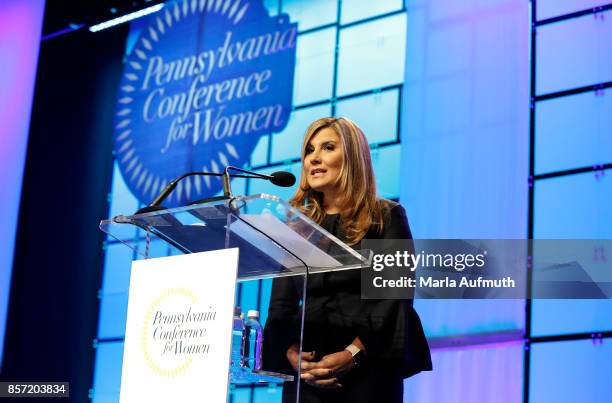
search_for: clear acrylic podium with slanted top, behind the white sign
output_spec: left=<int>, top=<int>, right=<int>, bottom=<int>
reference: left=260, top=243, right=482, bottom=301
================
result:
left=100, top=194, right=371, bottom=402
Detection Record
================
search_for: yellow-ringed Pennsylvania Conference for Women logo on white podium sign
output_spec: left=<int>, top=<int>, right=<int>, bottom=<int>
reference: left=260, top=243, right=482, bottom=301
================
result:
left=140, top=287, right=217, bottom=378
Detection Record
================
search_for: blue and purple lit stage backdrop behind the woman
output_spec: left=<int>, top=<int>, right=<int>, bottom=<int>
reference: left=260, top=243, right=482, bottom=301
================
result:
left=92, top=0, right=612, bottom=403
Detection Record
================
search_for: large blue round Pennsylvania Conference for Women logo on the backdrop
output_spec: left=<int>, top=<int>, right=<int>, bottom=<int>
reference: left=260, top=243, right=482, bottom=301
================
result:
left=114, top=0, right=297, bottom=207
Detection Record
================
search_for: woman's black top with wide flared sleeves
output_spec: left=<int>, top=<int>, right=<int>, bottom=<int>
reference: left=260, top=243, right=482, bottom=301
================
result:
left=264, top=202, right=432, bottom=378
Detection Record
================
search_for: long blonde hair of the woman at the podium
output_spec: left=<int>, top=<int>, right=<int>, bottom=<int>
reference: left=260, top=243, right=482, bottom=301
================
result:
left=289, top=118, right=383, bottom=245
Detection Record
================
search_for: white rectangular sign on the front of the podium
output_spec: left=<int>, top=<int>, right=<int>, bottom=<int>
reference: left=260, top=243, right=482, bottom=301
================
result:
left=120, top=248, right=238, bottom=403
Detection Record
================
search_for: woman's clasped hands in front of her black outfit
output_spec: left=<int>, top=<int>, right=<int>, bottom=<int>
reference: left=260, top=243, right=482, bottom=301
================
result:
left=301, top=350, right=355, bottom=388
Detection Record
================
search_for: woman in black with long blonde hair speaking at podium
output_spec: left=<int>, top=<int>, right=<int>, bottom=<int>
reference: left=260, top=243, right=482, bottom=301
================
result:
left=264, top=118, right=431, bottom=403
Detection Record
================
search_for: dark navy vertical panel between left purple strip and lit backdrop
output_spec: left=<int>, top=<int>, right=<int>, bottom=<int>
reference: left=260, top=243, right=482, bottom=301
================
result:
left=0, top=1, right=129, bottom=402
